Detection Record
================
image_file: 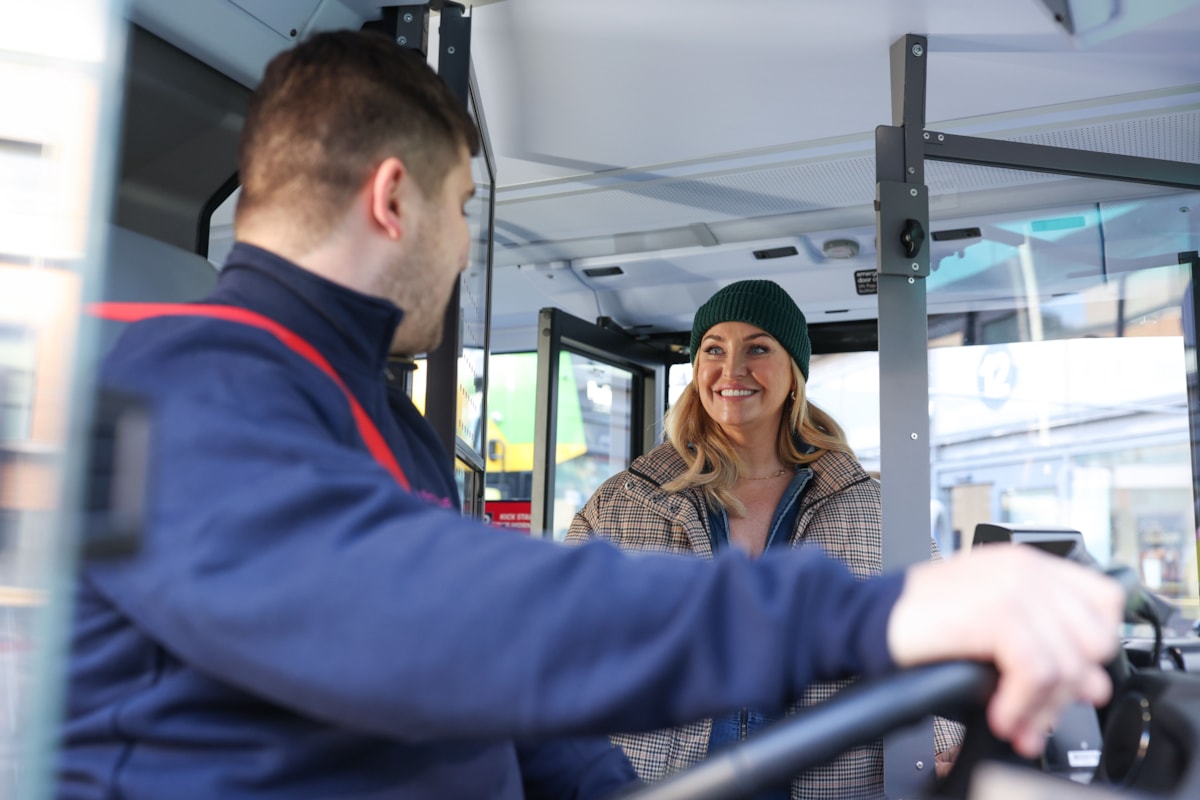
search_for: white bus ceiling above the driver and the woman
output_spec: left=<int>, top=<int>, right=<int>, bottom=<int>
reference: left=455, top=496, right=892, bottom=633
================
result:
left=131, top=0, right=1200, bottom=351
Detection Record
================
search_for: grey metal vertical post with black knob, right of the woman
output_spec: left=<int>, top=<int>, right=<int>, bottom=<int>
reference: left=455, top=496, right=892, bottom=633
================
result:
left=875, top=35, right=934, bottom=799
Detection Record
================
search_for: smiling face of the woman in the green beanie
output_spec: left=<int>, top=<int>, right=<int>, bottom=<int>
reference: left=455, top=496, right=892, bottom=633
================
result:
left=694, top=323, right=793, bottom=434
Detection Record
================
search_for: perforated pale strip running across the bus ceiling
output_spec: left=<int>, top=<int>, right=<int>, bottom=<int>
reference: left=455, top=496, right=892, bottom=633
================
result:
left=497, top=108, right=1200, bottom=262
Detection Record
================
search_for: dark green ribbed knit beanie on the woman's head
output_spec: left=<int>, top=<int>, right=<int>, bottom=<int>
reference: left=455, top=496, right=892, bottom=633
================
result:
left=690, top=281, right=812, bottom=380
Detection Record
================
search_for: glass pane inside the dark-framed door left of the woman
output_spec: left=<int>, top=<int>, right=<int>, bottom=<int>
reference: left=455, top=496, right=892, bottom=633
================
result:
left=552, top=350, right=634, bottom=540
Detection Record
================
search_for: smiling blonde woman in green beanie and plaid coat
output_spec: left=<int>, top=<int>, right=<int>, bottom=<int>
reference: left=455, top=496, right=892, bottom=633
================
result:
left=568, top=281, right=961, bottom=800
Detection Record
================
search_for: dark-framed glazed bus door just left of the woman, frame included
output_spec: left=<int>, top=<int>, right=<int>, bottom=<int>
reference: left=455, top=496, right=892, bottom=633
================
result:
left=529, top=308, right=682, bottom=540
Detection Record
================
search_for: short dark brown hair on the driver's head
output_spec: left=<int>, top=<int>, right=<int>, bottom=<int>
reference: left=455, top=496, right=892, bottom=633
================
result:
left=238, top=31, right=479, bottom=237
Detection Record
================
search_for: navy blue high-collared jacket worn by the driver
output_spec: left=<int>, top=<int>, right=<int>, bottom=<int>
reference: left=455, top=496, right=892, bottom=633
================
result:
left=59, top=245, right=902, bottom=800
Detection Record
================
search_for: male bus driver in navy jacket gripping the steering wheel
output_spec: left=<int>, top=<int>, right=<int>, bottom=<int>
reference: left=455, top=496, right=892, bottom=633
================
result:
left=59, top=32, right=1121, bottom=800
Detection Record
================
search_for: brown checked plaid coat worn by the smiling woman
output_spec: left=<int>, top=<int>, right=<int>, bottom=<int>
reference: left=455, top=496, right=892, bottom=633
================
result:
left=566, top=444, right=962, bottom=800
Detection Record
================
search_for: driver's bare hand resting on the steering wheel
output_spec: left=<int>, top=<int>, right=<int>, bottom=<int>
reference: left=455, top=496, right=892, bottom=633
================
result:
left=888, top=545, right=1124, bottom=758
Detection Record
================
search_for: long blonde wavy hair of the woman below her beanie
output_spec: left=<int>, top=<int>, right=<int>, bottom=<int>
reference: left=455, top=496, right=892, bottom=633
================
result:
left=662, top=361, right=854, bottom=516
